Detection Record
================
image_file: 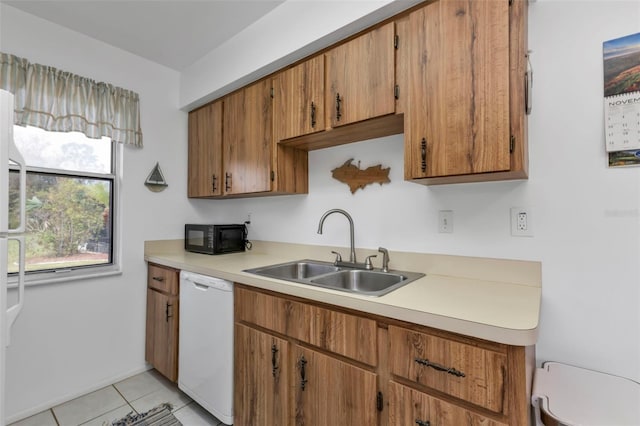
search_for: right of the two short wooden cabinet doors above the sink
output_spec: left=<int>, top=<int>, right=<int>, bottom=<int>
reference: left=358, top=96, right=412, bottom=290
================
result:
left=326, top=22, right=395, bottom=127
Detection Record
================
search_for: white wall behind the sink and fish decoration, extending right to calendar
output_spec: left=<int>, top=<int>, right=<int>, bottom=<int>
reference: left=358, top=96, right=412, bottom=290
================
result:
left=185, top=0, right=640, bottom=380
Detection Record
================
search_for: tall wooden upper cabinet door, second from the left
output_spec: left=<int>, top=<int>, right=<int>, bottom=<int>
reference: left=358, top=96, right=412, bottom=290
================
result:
left=222, top=80, right=273, bottom=195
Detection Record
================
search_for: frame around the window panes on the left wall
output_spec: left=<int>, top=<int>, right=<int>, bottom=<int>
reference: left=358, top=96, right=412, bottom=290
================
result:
left=8, top=133, right=123, bottom=288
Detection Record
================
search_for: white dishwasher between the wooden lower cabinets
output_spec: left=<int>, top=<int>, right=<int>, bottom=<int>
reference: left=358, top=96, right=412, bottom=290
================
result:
left=178, top=271, right=233, bottom=425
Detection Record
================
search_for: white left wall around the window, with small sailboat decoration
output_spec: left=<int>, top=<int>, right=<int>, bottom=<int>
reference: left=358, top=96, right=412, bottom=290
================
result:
left=0, top=4, right=190, bottom=420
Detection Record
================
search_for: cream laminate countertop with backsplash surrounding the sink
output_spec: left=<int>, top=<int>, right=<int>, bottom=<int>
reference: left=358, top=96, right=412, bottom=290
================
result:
left=144, top=240, right=542, bottom=346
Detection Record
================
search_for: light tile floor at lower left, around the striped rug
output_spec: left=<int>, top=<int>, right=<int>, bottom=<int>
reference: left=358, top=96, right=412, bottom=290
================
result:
left=9, top=370, right=224, bottom=426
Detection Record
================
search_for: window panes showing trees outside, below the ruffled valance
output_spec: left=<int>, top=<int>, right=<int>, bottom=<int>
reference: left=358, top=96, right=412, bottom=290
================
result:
left=9, top=126, right=117, bottom=274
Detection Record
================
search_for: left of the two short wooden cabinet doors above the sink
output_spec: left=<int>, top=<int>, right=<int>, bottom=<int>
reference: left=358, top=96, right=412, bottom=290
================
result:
left=273, top=55, right=325, bottom=143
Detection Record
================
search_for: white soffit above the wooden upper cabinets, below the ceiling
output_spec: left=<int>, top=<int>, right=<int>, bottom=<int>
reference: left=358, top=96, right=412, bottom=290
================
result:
left=180, top=0, right=421, bottom=111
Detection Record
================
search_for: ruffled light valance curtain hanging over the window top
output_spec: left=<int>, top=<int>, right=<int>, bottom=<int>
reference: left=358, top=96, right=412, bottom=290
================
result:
left=0, top=52, right=142, bottom=148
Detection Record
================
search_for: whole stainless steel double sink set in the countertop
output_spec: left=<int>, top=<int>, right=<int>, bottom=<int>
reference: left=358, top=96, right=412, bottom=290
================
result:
left=244, top=259, right=425, bottom=297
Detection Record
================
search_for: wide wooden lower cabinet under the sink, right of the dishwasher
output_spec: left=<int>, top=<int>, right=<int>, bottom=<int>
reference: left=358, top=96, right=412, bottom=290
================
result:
left=234, top=283, right=535, bottom=426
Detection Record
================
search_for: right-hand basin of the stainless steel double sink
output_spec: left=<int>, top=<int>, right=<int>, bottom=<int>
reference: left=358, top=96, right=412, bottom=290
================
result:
left=311, top=269, right=406, bottom=293
